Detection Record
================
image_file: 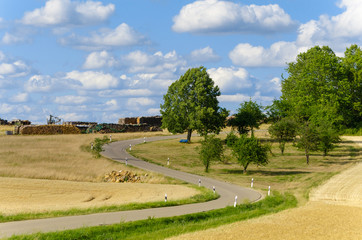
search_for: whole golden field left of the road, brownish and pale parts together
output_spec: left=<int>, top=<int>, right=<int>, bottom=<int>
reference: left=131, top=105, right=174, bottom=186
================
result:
left=0, top=133, right=198, bottom=215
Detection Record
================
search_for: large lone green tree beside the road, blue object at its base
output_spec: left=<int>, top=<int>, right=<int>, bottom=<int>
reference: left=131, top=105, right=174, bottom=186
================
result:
left=160, top=67, right=229, bottom=141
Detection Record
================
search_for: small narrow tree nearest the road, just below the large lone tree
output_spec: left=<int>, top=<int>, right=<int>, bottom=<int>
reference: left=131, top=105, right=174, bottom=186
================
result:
left=199, top=135, right=224, bottom=172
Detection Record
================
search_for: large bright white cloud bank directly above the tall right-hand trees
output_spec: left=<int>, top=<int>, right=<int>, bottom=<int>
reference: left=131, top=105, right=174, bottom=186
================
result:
left=229, top=0, right=362, bottom=67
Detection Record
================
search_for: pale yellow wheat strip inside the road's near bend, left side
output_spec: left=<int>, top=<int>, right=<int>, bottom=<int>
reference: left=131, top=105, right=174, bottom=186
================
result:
left=0, top=178, right=198, bottom=215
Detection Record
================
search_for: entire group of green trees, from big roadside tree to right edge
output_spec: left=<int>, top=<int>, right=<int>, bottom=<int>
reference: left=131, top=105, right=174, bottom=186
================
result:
left=161, top=45, right=362, bottom=171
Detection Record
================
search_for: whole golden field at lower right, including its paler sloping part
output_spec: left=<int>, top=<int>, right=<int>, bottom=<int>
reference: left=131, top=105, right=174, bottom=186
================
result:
left=172, top=137, right=362, bottom=240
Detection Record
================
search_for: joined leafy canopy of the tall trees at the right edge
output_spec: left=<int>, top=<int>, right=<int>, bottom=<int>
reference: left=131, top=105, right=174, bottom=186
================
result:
left=281, top=45, right=362, bottom=127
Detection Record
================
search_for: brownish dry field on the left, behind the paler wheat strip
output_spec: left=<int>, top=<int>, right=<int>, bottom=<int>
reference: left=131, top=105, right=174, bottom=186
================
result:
left=0, top=133, right=169, bottom=183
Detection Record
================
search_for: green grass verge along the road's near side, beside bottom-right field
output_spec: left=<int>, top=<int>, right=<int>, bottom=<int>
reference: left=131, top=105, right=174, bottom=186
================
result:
left=10, top=192, right=297, bottom=240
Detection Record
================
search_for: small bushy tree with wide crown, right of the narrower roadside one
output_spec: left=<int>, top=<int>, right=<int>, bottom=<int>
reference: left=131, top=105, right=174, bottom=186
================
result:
left=231, top=135, right=269, bottom=173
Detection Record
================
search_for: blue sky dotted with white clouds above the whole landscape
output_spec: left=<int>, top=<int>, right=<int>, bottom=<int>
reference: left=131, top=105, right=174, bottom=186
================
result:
left=0, top=0, right=362, bottom=123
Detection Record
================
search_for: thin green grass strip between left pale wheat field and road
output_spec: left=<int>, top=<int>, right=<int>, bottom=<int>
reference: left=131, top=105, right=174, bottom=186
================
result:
left=0, top=184, right=219, bottom=222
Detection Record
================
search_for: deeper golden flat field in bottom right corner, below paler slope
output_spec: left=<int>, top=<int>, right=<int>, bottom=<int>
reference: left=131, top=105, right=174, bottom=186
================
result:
left=171, top=202, right=362, bottom=240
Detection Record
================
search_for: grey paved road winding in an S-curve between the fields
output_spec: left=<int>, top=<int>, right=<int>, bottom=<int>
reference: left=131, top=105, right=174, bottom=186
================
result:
left=0, top=135, right=262, bottom=237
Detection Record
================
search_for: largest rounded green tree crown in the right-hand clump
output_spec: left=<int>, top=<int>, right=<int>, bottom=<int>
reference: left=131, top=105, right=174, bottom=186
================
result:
left=281, top=46, right=344, bottom=121
